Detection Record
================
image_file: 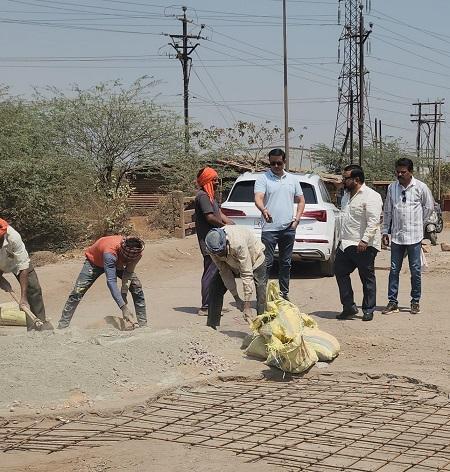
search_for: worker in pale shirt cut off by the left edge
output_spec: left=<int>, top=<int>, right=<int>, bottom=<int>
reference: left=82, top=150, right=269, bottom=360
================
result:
left=0, top=218, right=46, bottom=330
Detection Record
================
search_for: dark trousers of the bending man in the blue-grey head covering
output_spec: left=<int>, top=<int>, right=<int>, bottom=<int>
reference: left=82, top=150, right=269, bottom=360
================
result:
left=206, top=262, right=267, bottom=328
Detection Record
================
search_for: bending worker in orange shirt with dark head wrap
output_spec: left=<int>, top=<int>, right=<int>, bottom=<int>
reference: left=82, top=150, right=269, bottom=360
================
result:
left=58, top=235, right=147, bottom=329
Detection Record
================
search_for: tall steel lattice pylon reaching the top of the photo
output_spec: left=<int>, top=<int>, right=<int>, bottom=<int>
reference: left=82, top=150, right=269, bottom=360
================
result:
left=333, top=0, right=373, bottom=169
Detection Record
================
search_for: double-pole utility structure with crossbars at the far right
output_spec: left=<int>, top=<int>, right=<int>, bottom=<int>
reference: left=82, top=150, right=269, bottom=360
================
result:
left=411, top=99, right=445, bottom=199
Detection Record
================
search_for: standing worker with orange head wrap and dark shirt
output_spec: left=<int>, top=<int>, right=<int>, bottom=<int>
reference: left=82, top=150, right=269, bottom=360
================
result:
left=195, top=167, right=234, bottom=316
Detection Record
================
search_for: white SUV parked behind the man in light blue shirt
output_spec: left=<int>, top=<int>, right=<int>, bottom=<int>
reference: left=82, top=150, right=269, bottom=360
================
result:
left=221, top=172, right=340, bottom=276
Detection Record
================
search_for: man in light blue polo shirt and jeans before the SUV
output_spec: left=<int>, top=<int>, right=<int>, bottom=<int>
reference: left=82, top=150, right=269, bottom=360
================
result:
left=255, top=149, right=305, bottom=300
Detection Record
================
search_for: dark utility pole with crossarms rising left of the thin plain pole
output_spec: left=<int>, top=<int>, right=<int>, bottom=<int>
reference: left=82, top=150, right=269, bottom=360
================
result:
left=166, top=7, right=206, bottom=154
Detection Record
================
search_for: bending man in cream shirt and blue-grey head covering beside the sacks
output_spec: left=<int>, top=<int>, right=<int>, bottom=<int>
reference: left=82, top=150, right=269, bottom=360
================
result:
left=205, top=225, right=266, bottom=329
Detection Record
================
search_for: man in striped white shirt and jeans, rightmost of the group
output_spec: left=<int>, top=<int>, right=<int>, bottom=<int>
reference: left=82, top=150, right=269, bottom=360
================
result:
left=382, top=158, right=434, bottom=315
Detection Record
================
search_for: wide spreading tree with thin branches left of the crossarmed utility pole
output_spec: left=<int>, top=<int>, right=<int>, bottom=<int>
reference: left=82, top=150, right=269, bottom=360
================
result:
left=39, top=77, right=182, bottom=193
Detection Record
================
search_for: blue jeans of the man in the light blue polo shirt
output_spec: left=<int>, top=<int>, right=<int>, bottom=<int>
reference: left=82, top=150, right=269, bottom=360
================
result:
left=261, top=228, right=295, bottom=296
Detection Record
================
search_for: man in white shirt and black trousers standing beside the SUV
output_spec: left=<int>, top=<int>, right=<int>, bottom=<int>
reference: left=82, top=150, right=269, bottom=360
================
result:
left=334, top=164, right=383, bottom=321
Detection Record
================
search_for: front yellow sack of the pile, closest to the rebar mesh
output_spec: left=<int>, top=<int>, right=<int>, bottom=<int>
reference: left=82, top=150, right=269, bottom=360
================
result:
left=267, top=334, right=318, bottom=374
